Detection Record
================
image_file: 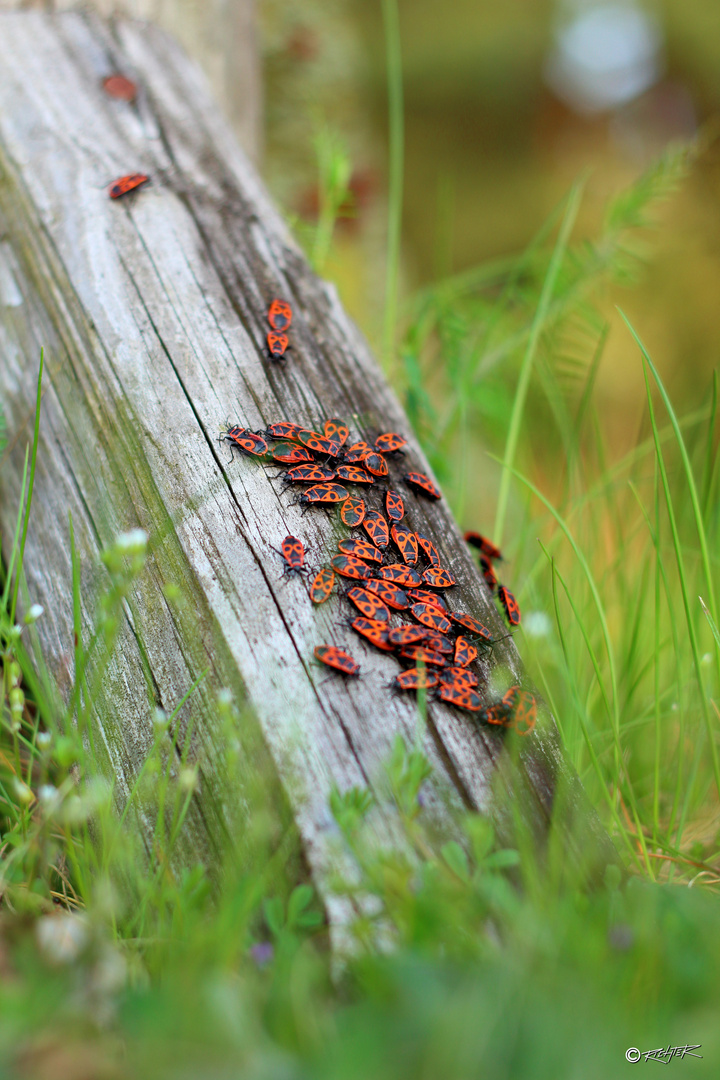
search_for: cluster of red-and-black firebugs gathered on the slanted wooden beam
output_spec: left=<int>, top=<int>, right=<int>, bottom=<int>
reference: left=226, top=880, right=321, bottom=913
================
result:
left=222, top=300, right=536, bottom=735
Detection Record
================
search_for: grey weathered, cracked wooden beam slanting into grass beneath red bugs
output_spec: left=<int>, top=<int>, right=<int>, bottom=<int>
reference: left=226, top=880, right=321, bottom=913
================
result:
left=0, top=12, right=612, bottom=920
